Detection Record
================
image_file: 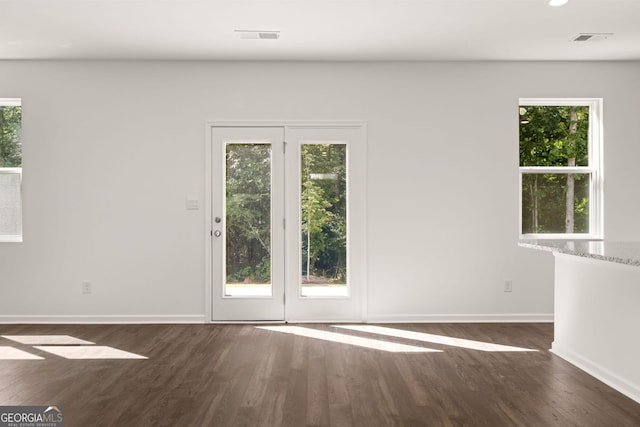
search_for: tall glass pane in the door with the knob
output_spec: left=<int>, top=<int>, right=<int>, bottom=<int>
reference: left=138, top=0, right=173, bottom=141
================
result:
left=224, top=143, right=272, bottom=296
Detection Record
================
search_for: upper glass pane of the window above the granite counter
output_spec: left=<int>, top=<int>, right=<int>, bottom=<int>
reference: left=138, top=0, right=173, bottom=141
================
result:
left=519, top=105, right=589, bottom=166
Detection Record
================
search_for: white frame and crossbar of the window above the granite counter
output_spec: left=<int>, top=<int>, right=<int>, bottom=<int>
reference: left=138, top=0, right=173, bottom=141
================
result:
left=518, top=98, right=604, bottom=240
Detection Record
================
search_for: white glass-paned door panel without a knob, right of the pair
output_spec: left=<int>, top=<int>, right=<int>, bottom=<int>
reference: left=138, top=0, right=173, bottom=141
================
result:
left=286, top=124, right=366, bottom=322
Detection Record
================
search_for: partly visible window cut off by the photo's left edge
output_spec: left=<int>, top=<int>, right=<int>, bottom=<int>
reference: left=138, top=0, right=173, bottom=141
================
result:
left=0, top=98, right=22, bottom=242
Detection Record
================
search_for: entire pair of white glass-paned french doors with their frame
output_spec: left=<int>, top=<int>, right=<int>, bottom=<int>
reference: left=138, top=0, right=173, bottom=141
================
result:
left=207, top=123, right=366, bottom=321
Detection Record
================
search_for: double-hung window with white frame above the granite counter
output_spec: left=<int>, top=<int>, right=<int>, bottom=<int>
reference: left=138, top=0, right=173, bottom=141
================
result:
left=519, top=99, right=602, bottom=239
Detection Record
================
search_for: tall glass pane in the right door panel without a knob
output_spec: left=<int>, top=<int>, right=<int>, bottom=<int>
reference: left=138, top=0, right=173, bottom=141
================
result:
left=300, top=144, right=348, bottom=296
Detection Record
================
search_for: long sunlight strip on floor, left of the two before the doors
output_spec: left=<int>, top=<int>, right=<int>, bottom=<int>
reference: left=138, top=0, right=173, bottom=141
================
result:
left=256, top=326, right=441, bottom=353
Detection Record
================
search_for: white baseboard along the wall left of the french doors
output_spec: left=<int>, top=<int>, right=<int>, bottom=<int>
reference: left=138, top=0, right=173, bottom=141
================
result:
left=0, top=314, right=205, bottom=324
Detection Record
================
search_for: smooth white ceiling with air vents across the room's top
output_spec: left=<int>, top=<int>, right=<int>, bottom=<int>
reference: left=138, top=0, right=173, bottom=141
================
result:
left=0, top=0, right=640, bottom=61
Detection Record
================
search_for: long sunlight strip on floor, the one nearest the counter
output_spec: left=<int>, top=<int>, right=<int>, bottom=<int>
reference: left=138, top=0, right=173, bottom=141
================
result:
left=333, top=325, right=538, bottom=352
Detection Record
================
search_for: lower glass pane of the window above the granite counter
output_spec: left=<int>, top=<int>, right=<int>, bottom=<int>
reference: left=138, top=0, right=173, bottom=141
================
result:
left=522, top=173, right=591, bottom=234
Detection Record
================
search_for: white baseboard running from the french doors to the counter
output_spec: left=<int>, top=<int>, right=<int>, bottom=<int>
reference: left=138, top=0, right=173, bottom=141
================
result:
left=367, top=313, right=553, bottom=323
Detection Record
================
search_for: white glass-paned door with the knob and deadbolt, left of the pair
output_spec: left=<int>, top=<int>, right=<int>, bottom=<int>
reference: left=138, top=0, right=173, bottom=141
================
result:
left=211, top=127, right=284, bottom=321
